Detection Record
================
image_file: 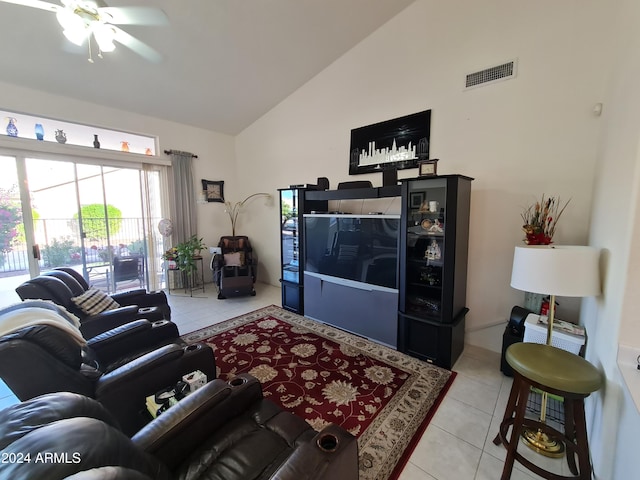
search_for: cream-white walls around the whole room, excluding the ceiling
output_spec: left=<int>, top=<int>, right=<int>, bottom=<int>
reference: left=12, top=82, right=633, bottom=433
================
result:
left=0, top=0, right=640, bottom=480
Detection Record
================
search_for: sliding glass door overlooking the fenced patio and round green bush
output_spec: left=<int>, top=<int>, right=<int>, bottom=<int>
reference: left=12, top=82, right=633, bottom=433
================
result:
left=0, top=157, right=161, bottom=304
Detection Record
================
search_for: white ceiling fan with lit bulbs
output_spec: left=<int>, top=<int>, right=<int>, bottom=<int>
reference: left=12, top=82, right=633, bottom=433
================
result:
left=0, top=0, right=169, bottom=63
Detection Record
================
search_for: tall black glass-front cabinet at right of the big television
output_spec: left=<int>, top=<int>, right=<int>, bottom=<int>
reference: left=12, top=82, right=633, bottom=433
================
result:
left=398, top=175, right=473, bottom=369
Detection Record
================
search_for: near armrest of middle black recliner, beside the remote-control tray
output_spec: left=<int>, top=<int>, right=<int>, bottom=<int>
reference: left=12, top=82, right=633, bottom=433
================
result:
left=95, top=344, right=216, bottom=435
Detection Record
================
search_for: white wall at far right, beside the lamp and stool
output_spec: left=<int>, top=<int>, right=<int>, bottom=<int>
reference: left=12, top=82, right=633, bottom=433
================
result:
left=582, top=0, right=640, bottom=479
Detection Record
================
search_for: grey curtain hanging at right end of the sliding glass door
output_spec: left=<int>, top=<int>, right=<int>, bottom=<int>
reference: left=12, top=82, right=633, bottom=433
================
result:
left=170, top=150, right=198, bottom=245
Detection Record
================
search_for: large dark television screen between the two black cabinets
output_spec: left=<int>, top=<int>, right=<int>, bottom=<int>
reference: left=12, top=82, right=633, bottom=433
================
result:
left=304, top=214, right=400, bottom=289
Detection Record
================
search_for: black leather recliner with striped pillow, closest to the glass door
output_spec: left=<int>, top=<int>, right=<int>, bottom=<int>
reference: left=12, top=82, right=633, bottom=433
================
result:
left=16, top=270, right=170, bottom=338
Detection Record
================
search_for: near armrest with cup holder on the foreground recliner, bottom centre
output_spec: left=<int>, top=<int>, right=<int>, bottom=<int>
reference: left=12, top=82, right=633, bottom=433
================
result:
left=272, top=424, right=359, bottom=480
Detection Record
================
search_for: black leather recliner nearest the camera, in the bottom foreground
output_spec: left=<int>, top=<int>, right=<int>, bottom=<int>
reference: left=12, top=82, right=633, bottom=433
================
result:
left=0, top=374, right=358, bottom=480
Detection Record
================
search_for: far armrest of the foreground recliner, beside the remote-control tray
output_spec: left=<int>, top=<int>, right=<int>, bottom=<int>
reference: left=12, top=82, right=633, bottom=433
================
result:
left=132, top=374, right=263, bottom=468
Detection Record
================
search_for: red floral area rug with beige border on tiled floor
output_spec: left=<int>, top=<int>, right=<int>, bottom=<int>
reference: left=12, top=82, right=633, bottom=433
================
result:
left=182, top=305, right=455, bottom=480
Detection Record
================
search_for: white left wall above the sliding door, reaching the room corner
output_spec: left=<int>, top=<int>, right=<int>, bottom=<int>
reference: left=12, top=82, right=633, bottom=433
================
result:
left=0, top=82, right=237, bottom=258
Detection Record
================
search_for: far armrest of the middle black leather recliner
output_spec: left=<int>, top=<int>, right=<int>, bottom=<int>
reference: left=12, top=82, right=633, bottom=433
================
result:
left=87, top=320, right=179, bottom=365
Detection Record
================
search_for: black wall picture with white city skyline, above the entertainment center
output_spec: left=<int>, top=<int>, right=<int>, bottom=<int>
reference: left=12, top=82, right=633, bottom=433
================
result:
left=349, top=110, right=431, bottom=175
